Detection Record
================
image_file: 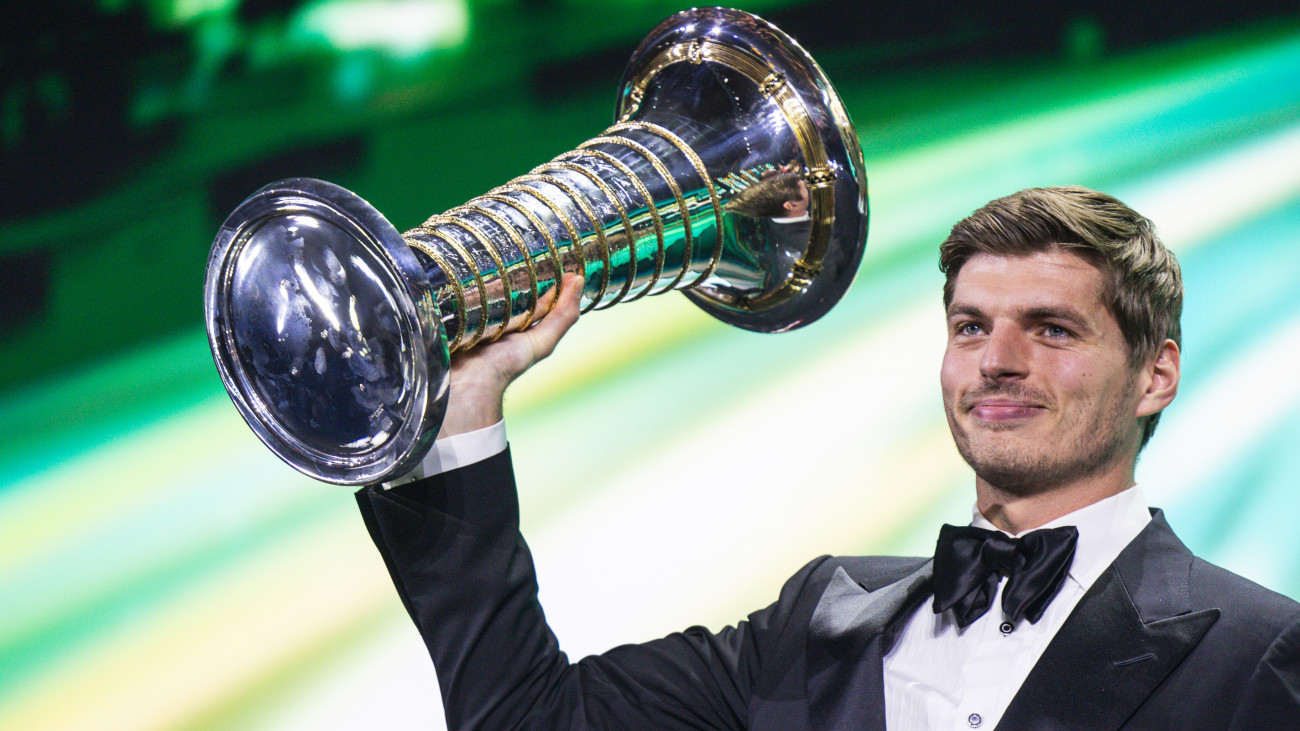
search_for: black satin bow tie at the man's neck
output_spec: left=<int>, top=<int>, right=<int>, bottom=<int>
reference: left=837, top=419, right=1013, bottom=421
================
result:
left=935, top=525, right=1079, bottom=628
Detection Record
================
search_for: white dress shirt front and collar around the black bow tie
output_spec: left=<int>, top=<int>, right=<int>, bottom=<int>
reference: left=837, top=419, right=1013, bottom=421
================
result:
left=884, top=486, right=1151, bottom=731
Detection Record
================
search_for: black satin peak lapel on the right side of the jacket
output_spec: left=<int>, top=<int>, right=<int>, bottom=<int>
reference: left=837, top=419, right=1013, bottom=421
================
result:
left=997, top=512, right=1219, bottom=731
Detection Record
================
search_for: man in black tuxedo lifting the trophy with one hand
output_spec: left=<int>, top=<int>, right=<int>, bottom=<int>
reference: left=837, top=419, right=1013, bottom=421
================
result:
left=359, top=187, right=1300, bottom=731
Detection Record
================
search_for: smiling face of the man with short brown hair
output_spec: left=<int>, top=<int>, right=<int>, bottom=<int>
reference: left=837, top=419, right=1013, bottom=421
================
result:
left=940, top=251, right=1147, bottom=494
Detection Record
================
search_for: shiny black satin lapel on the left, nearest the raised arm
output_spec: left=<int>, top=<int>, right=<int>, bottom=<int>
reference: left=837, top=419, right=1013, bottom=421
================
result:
left=807, top=562, right=931, bottom=731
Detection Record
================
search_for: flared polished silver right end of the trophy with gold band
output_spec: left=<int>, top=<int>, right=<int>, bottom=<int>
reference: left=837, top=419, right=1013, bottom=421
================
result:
left=616, top=8, right=867, bottom=332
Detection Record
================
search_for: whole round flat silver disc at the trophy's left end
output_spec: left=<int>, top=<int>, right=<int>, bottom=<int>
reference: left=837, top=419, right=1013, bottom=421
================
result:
left=204, top=178, right=450, bottom=485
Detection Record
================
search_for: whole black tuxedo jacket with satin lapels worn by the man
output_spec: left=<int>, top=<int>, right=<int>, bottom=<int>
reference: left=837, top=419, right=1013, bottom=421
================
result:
left=358, top=453, right=1300, bottom=731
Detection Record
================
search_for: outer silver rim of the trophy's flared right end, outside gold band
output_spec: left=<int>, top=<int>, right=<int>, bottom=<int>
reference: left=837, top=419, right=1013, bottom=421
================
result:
left=615, top=8, right=870, bottom=333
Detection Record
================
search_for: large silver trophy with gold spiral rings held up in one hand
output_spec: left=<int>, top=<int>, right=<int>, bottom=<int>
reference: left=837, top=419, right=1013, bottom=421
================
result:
left=204, top=8, right=867, bottom=485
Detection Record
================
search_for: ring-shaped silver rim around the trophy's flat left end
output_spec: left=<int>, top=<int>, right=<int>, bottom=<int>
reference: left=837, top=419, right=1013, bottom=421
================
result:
left=204, top=178, right=450, bottom=485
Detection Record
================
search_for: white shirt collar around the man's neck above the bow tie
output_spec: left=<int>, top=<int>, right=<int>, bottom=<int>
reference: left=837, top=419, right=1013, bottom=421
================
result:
left=971, top=485, right=1151, bottom=588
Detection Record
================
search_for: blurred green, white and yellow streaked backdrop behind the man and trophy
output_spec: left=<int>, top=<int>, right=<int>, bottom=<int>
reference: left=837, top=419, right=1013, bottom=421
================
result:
left=0, top=0, right=1300, bottom=731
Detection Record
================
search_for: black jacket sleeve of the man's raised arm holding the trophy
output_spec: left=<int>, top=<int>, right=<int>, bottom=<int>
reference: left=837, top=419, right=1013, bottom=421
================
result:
left=358, top=451, right=798, bottom=731
